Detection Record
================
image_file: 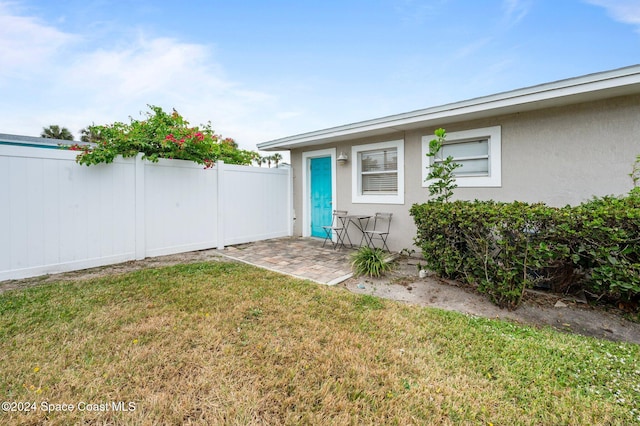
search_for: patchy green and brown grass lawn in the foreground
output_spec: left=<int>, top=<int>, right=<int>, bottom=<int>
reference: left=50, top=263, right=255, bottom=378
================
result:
left=0, top=262, right=640, bottom=425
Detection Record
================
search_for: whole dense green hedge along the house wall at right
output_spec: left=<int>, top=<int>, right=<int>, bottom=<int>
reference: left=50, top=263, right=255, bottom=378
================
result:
left=411, top=188, right=640, bottom=308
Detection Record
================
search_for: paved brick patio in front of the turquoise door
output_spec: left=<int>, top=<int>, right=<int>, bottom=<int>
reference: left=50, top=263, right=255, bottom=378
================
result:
left=223, top=237, right=353, bottom=285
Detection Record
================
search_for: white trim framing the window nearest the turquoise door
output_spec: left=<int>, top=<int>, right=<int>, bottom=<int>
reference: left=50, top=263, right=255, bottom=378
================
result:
left=351, top=139, right=404, bottom=204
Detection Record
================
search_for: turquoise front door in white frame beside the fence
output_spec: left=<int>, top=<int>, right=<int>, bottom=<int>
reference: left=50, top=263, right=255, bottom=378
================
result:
left=309, top=157, right=333, bottom=238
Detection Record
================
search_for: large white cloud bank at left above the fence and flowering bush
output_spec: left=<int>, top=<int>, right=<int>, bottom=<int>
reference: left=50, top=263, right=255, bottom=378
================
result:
left=0, top=3, right=294, bottom=149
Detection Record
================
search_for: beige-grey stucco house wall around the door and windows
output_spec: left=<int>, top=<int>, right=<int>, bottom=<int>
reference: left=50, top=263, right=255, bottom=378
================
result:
left=291, top=96, right=640, bottom=250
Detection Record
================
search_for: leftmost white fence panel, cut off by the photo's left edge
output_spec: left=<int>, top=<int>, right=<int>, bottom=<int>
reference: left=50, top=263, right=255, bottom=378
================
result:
left=0, top=147, right=135, bottom=280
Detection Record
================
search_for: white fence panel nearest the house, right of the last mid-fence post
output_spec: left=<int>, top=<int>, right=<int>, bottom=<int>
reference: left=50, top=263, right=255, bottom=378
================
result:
left=220, top=165, right=292, bottom=245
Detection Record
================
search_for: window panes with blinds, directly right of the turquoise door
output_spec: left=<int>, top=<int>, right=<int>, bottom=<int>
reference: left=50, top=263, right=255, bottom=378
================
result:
left=358, top=148, right=398, bottom=195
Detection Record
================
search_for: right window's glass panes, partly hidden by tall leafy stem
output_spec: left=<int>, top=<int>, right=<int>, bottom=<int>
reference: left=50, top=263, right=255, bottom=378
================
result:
left=433, top=139, right=489, bottom=177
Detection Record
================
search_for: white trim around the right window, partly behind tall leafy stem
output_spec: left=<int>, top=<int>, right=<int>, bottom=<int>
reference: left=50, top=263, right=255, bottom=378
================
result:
left=422, top=126, right=502, bottom=188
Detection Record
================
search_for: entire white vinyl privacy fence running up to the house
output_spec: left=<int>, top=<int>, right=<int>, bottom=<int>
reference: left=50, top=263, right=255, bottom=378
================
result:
left=0, top=145, right=293, bottom=281
